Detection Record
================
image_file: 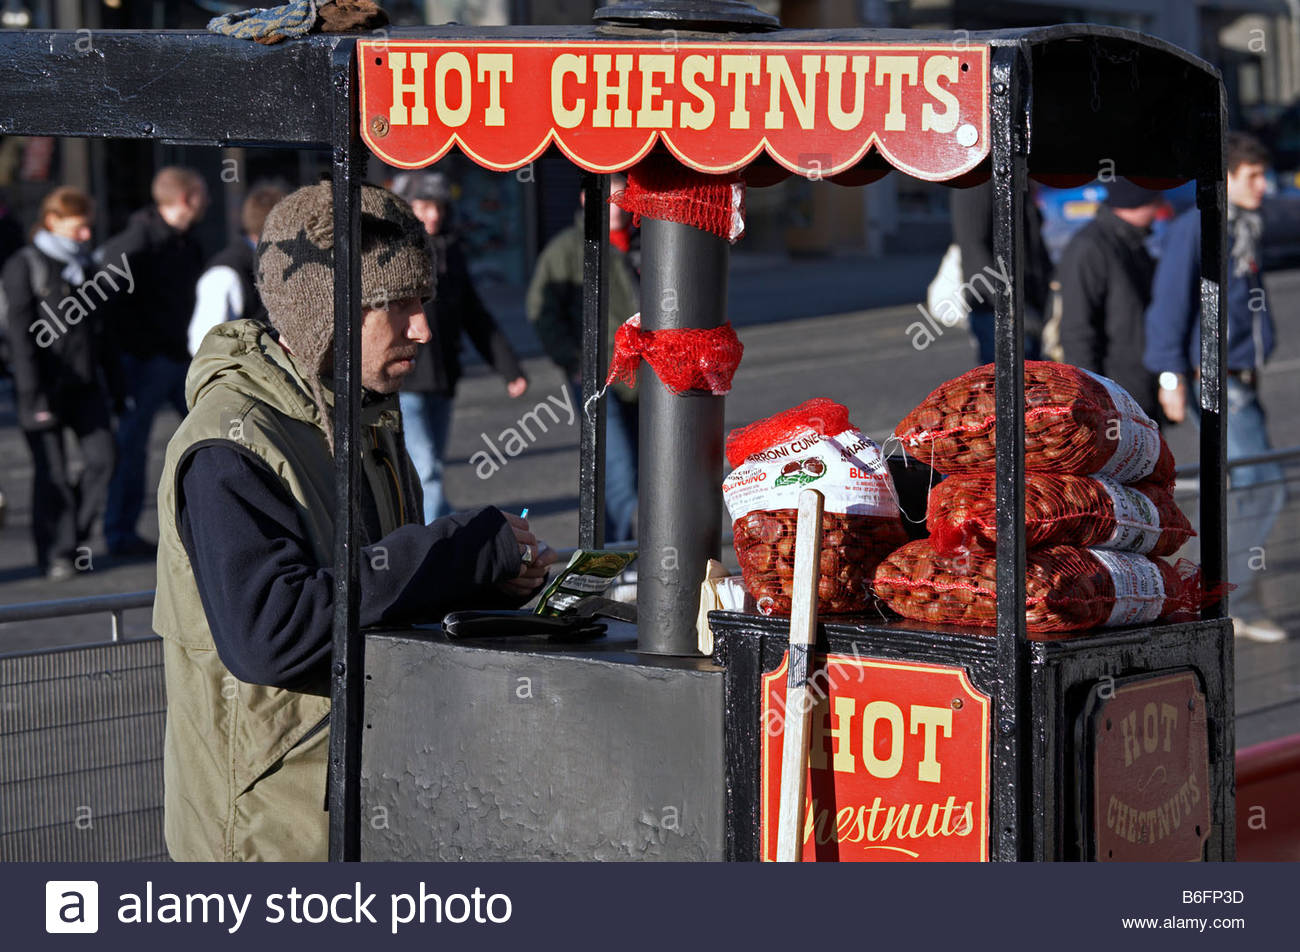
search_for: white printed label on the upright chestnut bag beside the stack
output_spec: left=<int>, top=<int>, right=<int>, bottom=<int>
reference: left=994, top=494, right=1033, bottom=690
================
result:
left=723, top=429, right=898, bottom=522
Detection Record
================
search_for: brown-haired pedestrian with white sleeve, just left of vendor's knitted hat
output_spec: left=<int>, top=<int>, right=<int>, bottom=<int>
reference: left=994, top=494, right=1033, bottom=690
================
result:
left=190, top=185, right=285, bottom=354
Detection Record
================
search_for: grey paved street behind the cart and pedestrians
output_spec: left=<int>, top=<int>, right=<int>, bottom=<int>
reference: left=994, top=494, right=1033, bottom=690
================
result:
left=0, top=255, right=1300, bottom=744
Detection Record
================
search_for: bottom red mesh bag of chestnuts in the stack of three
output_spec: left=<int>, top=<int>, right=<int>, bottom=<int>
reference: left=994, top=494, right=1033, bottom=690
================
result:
left=875, top=538, right=1205, bottom=632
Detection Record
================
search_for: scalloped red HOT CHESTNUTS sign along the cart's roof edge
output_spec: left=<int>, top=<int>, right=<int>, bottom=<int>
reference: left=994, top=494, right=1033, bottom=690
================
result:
left=358, top=40, right=989, bottom=181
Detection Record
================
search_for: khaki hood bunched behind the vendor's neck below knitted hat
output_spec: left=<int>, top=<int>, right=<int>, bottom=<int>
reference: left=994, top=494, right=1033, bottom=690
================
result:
left=185, top=320, right=321, bottom=428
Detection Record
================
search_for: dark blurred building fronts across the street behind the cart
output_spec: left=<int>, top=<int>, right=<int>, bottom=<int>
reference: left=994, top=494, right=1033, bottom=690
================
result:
left=0, top=0, right=1300, bottom=277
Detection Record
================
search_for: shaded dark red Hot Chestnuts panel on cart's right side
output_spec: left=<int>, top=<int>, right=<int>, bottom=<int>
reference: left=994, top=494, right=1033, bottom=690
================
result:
left=1089, top=671, right=1210, bottom=862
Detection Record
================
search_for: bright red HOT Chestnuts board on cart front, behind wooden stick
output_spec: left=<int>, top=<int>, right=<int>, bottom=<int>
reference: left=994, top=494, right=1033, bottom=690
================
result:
left=759, top=654, right=989, bottom=862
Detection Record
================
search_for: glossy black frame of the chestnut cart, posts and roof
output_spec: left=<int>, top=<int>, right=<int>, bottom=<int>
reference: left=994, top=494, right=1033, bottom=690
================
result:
left=0, top=14, right=1232, bottom=860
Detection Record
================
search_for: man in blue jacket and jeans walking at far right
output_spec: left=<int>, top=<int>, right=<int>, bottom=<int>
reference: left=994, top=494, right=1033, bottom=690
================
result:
left=1143, top=133, right=1287, bottom=641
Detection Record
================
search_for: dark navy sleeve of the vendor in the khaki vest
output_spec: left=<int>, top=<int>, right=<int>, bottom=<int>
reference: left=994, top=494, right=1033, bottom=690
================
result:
left=178, top=445, right=520, bottom=687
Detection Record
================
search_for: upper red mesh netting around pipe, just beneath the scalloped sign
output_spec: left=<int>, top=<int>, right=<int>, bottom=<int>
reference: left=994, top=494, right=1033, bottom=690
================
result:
left=610, top=155, right=745, bottom=242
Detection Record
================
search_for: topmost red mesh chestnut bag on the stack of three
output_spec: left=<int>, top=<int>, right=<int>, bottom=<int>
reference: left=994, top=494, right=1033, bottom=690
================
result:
left=894, top=360, right=1174, bottom=483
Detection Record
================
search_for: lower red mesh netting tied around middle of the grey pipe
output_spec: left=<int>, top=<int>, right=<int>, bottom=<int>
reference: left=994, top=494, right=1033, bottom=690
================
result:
left=605, top=315, right=745, bottom=397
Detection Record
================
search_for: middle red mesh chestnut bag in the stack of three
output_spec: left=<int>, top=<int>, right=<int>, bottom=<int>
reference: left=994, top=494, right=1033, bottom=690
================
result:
left=926, top=472, right=1196, bottom=555
